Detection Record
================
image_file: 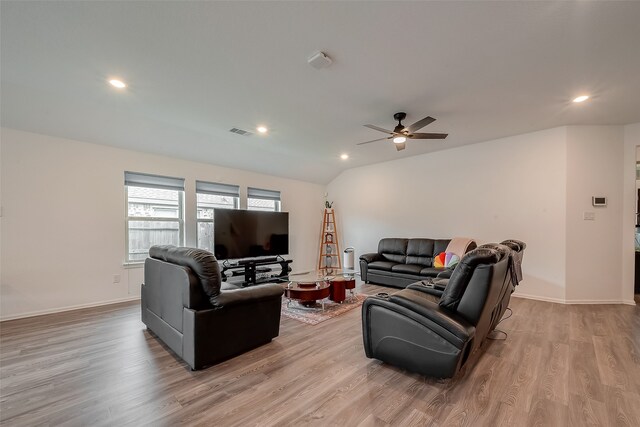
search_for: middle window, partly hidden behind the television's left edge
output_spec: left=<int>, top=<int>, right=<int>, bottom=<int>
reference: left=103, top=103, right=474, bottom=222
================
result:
left=196, top=181, right=240, bottom=252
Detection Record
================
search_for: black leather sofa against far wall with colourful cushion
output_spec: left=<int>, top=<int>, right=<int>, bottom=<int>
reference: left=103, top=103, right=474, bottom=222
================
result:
left=360, top=238, right=476, bottom=288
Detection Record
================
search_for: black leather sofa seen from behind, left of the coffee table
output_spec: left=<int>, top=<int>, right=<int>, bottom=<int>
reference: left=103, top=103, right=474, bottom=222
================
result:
left=141, top=246, right=284, bottom=370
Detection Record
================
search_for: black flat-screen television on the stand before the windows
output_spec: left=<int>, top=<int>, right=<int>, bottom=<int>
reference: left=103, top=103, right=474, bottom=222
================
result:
left=213, top=209, right=289, bottom=259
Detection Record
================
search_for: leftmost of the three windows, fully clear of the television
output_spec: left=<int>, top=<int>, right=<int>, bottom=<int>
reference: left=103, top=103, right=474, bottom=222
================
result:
left=124, top=172, right=184, bottom=262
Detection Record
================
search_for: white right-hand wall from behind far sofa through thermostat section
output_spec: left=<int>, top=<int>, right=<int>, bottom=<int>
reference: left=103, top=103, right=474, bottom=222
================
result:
left=328, top=125, right=640, bottom=303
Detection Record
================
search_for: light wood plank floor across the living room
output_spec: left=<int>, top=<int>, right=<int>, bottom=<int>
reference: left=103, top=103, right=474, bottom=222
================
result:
left=0, top=285, right=640, bottom=426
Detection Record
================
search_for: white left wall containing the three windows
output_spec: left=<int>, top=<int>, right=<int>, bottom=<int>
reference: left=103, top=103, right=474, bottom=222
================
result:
left=0, top=128, right=325, bottom=319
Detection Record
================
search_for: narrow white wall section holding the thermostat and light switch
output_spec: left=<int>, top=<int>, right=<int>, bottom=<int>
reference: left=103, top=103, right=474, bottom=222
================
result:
left=566, top=126, right=624, bottom=302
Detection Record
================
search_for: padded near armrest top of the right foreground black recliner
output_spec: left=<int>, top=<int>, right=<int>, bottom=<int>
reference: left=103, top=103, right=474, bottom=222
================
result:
left=389, top=289, right=476, bottom=341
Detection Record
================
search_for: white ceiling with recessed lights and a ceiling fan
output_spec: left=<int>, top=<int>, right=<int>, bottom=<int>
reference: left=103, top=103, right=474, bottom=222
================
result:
left=0, top=1, right=640, bottom=183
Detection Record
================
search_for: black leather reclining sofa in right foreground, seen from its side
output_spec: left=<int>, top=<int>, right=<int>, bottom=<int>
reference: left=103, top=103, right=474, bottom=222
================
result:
left=362, top=244, right=524, bottom=378
